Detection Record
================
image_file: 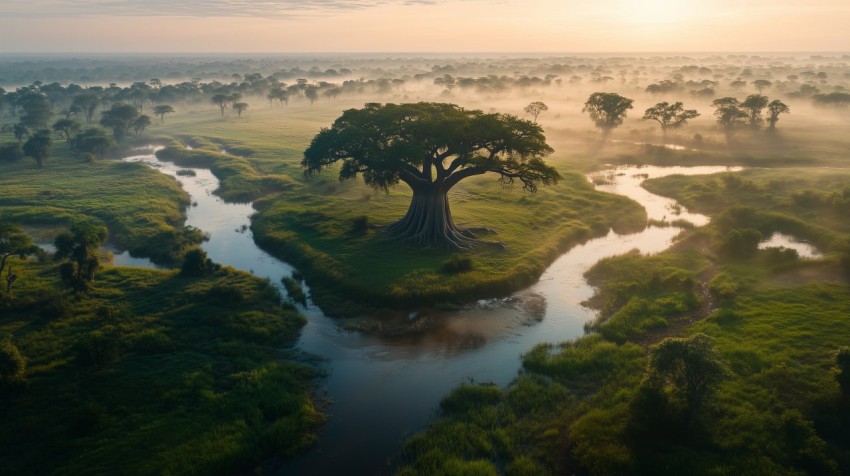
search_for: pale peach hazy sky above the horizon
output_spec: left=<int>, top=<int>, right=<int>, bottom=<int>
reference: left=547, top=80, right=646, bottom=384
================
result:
left=0, top=0, right=850, bottom=53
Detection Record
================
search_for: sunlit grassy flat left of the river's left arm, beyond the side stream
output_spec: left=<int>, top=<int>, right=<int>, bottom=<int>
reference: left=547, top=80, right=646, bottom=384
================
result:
left=0, top=144, right=199, bottom=264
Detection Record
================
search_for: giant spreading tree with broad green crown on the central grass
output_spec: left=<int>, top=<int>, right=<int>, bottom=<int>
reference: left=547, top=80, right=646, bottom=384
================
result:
left=301, top=103, right=560, bottom=248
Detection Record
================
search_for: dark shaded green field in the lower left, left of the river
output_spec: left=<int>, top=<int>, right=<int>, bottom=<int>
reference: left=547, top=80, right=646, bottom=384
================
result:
left=0, top=261, right=323, bottom=474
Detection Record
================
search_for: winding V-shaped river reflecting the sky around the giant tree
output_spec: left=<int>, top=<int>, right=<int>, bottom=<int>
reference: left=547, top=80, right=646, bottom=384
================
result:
left=124, top=148, right=740, bottom=475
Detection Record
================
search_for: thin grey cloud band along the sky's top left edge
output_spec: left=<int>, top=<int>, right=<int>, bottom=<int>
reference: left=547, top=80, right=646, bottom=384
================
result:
left=0, top=0, right=448, bottom=18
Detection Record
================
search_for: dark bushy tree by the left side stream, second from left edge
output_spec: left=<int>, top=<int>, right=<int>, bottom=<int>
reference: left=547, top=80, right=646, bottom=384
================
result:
left=54, top=223, right=106, bottom=299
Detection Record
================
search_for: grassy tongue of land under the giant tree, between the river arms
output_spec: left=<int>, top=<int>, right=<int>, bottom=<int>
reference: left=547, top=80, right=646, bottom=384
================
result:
left=112, top=104, right=646, bottom=315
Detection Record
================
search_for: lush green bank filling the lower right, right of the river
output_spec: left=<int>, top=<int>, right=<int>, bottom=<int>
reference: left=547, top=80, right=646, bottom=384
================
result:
left=401, top=165, right=850, bottom=475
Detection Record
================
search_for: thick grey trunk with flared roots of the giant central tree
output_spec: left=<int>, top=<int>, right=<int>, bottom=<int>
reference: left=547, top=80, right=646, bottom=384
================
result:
left=386, top=183, right=477, bottom=249
